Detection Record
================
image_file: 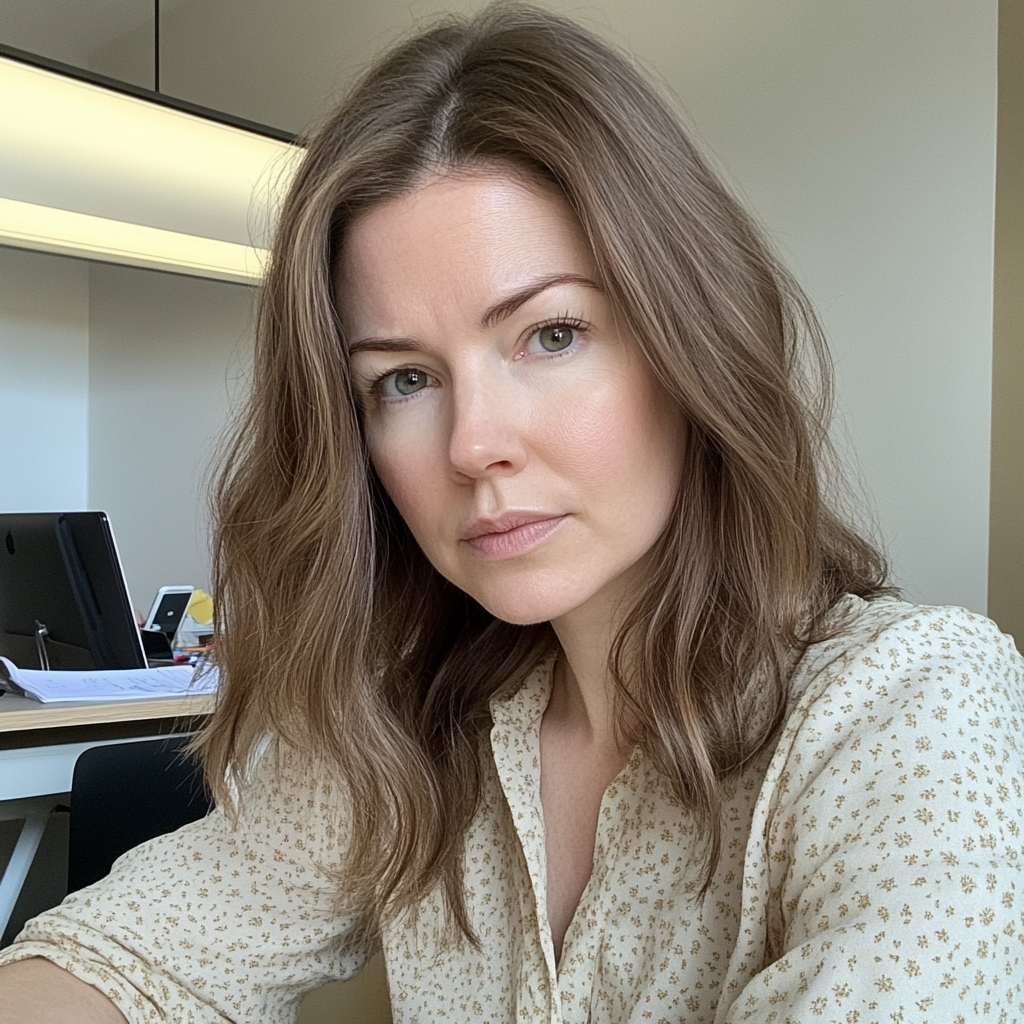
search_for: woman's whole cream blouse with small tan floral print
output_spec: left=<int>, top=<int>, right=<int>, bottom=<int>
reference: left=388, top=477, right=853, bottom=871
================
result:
left=0, top=598, right=1024, bottom=1024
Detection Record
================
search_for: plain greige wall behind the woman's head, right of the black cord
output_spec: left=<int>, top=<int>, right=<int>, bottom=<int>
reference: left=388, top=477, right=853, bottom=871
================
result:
left=117, top=0, right=997, bottom=609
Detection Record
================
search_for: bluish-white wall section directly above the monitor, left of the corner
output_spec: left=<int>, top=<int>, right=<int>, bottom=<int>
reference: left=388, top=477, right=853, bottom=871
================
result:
left=0, top=249, right=89, bottom=512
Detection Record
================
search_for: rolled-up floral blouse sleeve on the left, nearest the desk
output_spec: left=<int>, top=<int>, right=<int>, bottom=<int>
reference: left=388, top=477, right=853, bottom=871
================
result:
left=0, top=744, right=375, bottom=1024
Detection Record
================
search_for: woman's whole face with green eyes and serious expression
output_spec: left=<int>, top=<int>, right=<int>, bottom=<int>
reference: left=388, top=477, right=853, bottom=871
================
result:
left=337, top=170, right=684, bottom=624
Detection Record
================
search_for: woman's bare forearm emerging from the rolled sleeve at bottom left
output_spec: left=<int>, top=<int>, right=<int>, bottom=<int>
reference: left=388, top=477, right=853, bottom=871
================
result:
left=0, top=958, right=127, bottom=1024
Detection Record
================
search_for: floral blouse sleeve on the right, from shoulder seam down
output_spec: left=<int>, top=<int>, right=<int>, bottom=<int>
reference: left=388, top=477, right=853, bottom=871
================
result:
left=719, top=608, right=1024, bottom=1024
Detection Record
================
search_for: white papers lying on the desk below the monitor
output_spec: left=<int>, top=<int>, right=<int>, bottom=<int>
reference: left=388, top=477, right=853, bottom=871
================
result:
left=0, top=657, right=217, bottom=703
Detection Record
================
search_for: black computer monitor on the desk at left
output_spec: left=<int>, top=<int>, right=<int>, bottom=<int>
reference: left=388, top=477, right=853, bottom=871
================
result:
left=0, top=512, right=146, bottom=670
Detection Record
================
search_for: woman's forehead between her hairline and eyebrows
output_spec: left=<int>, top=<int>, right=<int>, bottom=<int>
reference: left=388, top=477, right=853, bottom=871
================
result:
left=336, top=170, right=594, bottom=331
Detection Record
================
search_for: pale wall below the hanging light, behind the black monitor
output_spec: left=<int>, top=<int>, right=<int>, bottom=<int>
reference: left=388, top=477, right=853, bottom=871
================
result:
left=0, top=249, right=255, bottom=611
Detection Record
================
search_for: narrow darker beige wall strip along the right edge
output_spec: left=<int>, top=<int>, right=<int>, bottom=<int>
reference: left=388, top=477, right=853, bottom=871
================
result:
left=988, top=0, right=1024, bottom=646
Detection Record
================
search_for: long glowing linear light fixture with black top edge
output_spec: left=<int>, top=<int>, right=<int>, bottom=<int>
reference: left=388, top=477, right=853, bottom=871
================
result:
left=0, top=47, right=301, bottom=284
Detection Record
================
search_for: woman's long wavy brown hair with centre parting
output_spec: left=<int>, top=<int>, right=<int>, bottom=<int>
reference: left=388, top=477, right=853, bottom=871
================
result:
left=201, top=4, right=888, bottom=938
